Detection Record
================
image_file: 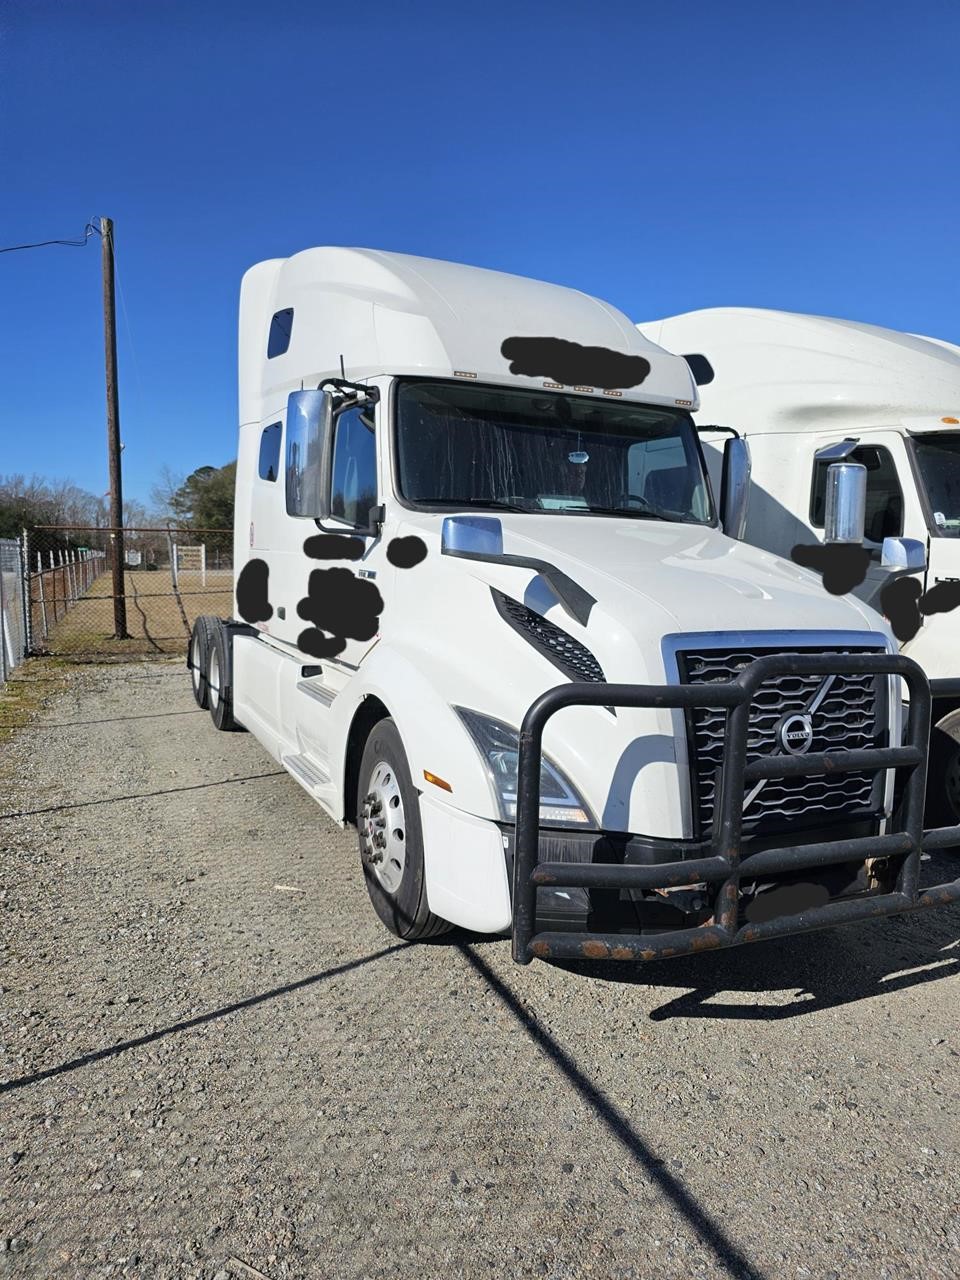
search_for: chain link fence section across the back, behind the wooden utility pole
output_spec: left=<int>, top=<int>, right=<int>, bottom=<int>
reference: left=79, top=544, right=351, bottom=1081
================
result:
left=22, top=525, right=233, bottom=658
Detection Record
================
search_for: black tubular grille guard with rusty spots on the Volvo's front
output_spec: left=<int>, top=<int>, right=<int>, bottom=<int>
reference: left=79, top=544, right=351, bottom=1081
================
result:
left=513, top=653, right=960, bottom=964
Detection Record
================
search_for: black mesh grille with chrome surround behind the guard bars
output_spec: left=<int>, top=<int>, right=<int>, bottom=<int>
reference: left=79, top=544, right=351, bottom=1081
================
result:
left=677, top=646, right=886, bottom=838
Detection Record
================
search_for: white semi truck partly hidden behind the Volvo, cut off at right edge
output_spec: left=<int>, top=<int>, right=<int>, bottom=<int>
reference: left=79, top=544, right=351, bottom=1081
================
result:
left=639, top=307, right=960, bottom=823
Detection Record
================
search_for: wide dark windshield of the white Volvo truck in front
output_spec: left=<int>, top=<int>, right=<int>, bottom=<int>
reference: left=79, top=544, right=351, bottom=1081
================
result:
left=397, top=381, right=714, bottom=525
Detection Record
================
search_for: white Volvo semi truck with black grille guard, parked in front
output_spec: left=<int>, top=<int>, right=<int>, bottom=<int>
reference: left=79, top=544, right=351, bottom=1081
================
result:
left=188, top=248, right=960, bottom=963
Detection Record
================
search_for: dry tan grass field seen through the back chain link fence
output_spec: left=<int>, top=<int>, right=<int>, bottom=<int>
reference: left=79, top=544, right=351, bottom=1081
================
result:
left=32, top=570, right=233, bottom=657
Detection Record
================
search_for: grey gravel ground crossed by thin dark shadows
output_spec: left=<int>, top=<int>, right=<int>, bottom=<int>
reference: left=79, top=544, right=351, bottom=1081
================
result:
left=0, top=663, right=960, bottom=1280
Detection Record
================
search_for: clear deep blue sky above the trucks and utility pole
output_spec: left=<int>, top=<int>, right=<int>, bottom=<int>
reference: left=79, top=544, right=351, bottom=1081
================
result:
left=0, top=0, right=960, bottom=499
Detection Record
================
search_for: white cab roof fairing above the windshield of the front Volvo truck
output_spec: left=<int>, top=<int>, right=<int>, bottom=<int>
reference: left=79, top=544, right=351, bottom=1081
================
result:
left=239, top=247, right=698, bottom=422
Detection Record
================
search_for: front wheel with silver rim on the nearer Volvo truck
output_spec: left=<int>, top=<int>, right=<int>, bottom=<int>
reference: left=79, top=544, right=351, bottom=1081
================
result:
left=357, top=719, right=452, bottom=942
